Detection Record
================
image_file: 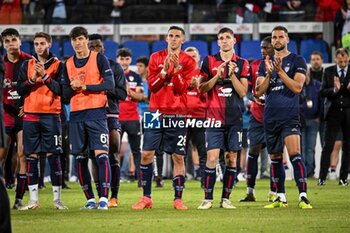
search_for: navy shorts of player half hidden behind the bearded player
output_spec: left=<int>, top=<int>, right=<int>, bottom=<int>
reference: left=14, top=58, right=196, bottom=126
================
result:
left=248, top=115, right=266, bottom=147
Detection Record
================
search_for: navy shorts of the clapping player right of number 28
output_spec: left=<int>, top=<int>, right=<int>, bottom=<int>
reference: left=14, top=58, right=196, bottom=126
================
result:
left=206, top=125, right=243, bottom=151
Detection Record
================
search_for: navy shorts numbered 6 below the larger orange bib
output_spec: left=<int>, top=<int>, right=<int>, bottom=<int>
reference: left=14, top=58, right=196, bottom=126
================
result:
left=69, top=119, right=109, bottom=154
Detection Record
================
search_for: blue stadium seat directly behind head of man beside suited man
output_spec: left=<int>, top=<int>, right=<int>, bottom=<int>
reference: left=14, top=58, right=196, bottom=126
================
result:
left=300, top=39, right=329, bottom=63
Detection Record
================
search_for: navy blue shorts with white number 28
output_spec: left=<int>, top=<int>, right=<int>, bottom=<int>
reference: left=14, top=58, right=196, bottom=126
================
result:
left=143, top=117, right=187, bottom=155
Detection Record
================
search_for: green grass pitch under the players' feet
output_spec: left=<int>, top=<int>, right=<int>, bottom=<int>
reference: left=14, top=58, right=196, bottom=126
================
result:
left=9, top=179, right=350, bottom=233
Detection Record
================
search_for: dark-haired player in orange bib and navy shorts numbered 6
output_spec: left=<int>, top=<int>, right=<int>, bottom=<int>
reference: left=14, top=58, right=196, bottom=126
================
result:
left=62, top=26, right=115, bottom=210
